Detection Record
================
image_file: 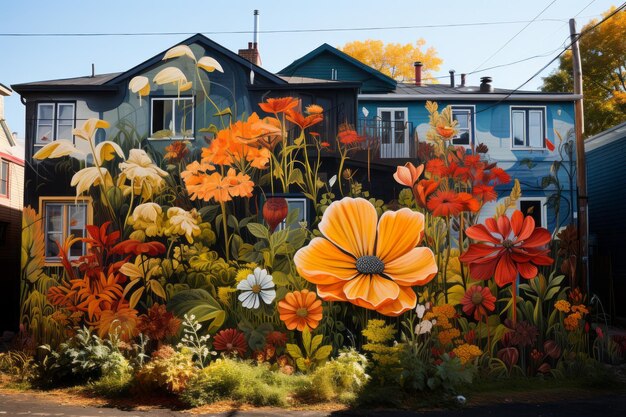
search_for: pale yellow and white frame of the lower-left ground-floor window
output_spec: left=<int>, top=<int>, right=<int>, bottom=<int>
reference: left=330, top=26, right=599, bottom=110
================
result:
left=39, top=197, right=93, bottom=266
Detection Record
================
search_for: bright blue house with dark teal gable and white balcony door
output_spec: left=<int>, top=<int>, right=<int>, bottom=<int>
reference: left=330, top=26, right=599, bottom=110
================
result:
left=279, top=44, right=578, bottom=230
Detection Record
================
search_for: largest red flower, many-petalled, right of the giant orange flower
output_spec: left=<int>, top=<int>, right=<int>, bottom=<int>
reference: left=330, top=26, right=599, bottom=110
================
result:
left=460, top=210, right=554, bottom=287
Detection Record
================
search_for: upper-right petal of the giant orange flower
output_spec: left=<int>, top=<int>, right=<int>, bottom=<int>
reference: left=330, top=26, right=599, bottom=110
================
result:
left=376, top=208, right=424, bottom=264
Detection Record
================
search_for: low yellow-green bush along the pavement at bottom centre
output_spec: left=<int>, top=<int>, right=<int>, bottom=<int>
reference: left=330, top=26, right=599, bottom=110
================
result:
left=180, top=359, right=303, bottom=407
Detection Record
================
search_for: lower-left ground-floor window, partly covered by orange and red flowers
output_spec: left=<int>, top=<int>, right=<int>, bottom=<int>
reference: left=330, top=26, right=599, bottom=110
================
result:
left=41, top=198, right=89, bottom=263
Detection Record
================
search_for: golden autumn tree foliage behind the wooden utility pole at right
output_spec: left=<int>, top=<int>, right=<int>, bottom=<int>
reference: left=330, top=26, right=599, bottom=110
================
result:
left=542, top=7, right=626, bottom=136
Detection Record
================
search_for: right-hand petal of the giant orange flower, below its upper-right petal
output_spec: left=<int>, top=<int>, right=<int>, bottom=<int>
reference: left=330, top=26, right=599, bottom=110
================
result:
left=384, top=248, right=437, bottom=286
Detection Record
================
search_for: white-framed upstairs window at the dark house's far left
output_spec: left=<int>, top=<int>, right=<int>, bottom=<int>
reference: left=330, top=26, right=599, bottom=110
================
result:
left=35, top=103, right=75, bottom=146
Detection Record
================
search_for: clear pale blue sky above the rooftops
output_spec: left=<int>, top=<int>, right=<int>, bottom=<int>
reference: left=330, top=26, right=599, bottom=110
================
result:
left=0, top=0, right=615, bottom=137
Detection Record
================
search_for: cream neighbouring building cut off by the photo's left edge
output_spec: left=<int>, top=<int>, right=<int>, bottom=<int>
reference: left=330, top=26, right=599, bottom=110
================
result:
left=0, top=84, right=24, bottom=333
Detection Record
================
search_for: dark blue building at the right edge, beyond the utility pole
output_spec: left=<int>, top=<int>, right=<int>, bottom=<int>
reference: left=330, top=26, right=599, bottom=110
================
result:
left=585, top=122, right=626, bottom=319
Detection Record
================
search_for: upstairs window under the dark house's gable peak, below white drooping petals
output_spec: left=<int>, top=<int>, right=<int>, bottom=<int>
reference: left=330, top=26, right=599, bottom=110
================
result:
left=150, top=97, right=194, bottom=139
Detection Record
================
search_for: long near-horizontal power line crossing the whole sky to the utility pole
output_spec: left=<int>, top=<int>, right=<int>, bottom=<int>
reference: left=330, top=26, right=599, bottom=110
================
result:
left=0, top=17, right=567, bottom=37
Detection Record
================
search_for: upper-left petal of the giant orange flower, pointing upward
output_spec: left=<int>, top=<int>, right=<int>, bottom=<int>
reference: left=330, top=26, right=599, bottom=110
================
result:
left=319, top=197, right=378, bottom=258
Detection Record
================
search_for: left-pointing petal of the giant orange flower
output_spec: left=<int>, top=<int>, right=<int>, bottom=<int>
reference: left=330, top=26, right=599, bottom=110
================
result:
left=293, top=237, right=357, bottom=285
